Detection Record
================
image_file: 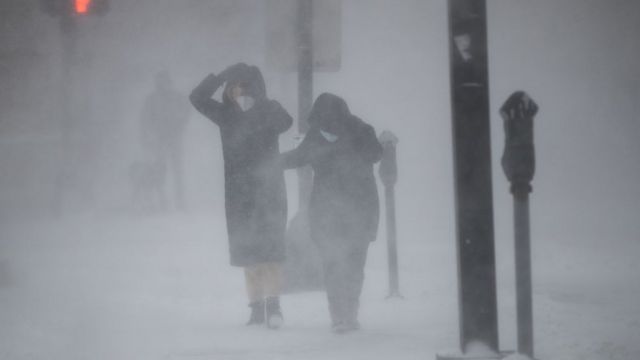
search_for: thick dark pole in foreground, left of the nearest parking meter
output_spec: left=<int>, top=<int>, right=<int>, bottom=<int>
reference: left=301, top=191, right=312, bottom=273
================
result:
left=438, top=0, right=500, bottom=359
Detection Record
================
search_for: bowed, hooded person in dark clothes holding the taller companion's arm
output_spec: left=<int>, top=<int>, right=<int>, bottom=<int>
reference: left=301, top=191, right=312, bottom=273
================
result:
left=282, top=93, right=382, bottom=333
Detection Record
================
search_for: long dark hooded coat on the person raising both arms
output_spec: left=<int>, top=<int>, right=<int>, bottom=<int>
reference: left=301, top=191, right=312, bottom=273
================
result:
left=190, top=66, right=293, bottom=266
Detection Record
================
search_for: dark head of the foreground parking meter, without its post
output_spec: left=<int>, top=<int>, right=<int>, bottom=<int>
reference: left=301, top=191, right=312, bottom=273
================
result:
left=500, top=91, right=538, bottom=197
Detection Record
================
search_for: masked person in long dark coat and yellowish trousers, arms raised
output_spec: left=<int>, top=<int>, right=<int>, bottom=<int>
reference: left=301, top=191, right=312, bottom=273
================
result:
left=190, top=63, right=293, bottom=328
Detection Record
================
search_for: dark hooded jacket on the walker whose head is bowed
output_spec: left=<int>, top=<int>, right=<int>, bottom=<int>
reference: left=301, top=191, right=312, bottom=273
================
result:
left=283, top=93, right=382, bottom=242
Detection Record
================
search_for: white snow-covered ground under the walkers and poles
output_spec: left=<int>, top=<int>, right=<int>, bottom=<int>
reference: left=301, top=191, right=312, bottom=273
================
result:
left=0, top=214, right=640, bottom=360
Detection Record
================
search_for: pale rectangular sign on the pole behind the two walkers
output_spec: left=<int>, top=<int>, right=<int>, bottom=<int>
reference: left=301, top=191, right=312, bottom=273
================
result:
left=266, top=0, right=342, bottom=72
